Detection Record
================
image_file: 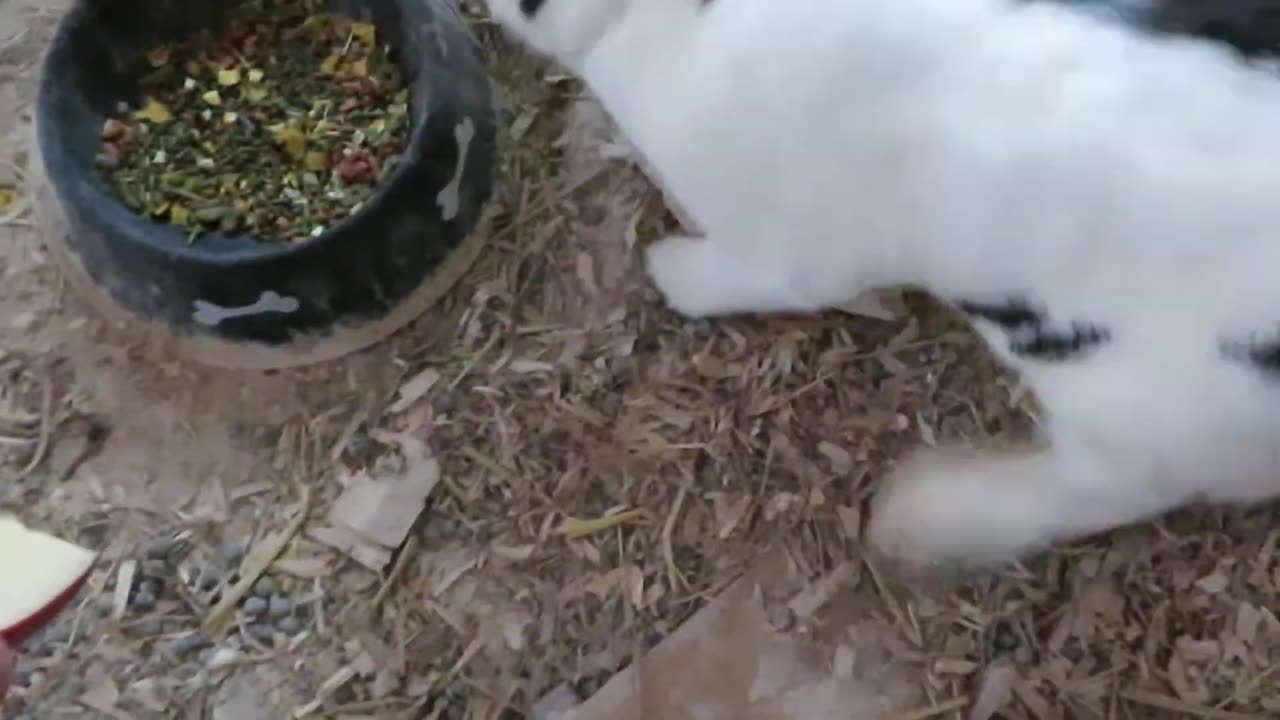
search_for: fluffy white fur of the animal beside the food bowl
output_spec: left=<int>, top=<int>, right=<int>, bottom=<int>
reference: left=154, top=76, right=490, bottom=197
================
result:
left=489, top=0, right=1280, bottom=566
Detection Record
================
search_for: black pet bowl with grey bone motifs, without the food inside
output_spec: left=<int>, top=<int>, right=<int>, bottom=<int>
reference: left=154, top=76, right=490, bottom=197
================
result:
left=37, top=0, right=497, bottom=365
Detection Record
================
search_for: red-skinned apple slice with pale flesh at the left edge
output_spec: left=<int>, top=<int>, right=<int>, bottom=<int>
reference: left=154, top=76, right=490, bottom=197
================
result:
left=0, top=515, right=97, bottom=646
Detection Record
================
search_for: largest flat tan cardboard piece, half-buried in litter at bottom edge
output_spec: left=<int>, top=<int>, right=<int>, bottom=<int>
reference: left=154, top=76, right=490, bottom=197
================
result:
left=565, top=553, right=919, bottom=720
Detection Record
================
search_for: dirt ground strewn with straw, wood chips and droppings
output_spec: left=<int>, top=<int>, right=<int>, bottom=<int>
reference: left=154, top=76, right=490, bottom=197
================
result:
left=0, top=0, right=1280, bottom=720
